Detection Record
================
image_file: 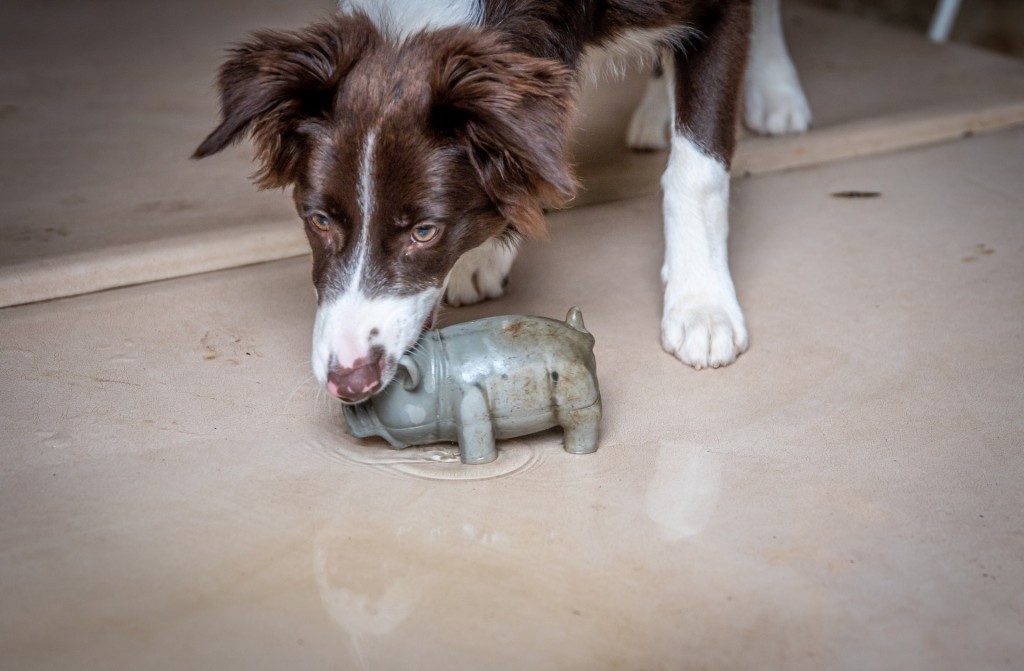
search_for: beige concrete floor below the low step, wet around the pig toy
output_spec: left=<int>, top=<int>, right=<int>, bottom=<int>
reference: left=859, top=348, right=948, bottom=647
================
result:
left=0, top=1, right=1024, bottom=671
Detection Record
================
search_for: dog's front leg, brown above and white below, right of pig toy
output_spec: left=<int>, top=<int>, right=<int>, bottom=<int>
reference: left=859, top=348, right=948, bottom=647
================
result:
left=662, top=2, right=750, bottom=369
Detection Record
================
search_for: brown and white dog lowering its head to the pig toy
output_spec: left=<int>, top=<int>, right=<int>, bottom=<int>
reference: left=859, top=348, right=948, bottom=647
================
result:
left=196, top=0, right=809, bottom=403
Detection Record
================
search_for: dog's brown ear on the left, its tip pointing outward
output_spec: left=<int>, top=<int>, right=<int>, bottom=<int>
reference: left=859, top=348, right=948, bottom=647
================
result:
left=193, top=15, right=380, bottom=188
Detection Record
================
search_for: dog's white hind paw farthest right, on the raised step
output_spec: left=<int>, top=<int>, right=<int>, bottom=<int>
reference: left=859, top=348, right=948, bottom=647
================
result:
left=743, top=61, right=811, bottom=135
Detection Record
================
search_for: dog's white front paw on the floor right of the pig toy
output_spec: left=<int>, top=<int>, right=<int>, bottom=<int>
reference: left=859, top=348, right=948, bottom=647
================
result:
left=662, top=297, right=749, bottom=370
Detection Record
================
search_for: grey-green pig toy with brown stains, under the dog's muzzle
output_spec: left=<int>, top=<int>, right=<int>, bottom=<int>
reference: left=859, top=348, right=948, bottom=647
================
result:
left=344, top=307, right=601, bottom=464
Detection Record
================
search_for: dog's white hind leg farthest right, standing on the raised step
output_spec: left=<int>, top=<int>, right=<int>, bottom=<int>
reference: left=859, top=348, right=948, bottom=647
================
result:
left=743, top=0, right=811, bottom=135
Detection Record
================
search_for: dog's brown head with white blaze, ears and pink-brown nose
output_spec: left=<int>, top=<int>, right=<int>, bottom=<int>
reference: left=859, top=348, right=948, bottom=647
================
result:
left=195, top=15, right=574, bottom=403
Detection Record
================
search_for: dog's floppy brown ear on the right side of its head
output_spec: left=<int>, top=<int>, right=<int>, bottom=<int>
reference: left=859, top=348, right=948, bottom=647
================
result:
left=431, top=31, right=577, bottom=238
